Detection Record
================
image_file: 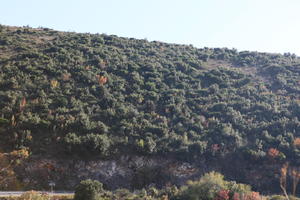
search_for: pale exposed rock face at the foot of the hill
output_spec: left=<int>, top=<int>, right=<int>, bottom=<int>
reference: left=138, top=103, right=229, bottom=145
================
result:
left=18, top=156, right=200, bottom=189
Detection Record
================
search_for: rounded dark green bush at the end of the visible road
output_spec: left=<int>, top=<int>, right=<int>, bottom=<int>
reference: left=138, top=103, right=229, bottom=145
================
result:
left=74, top=179, right=103, bottom=200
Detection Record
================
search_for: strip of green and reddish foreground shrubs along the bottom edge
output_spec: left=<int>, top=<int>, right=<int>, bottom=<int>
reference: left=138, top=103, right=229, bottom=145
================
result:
left=74, top=172, right=298, bottom=200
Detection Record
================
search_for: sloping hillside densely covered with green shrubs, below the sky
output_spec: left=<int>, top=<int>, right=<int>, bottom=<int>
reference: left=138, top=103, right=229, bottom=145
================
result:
left=0, top=26, right=300, bottom=190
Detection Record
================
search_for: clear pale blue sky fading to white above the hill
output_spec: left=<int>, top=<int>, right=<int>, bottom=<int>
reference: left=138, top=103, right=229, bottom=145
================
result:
left=0, top=0, right=300, bottom=55
